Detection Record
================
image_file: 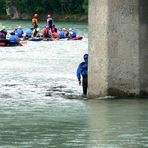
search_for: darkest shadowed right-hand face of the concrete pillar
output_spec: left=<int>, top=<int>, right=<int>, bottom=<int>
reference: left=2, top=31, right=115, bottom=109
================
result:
left=139, top=0, right=148, bottom=95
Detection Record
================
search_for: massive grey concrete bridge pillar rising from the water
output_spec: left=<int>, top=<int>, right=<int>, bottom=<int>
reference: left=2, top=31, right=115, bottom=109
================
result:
left=88, top=0, right=148, bottom=98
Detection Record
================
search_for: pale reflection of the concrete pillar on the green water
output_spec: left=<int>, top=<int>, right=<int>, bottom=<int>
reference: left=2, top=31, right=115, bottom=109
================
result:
left=89, top=99, right=148, bottom=148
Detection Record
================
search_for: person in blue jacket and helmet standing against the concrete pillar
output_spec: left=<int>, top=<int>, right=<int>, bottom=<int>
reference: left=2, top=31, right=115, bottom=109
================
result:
left=77, top=54, right=88, bottom=96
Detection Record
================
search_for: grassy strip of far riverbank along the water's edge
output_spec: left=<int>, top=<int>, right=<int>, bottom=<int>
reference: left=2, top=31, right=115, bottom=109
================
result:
left=0, top=14, right=88, bottom=23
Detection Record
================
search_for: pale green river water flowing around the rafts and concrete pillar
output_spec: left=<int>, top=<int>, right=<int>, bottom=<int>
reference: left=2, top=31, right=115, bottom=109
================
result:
left=0, top=20, right=148, bottom=148
